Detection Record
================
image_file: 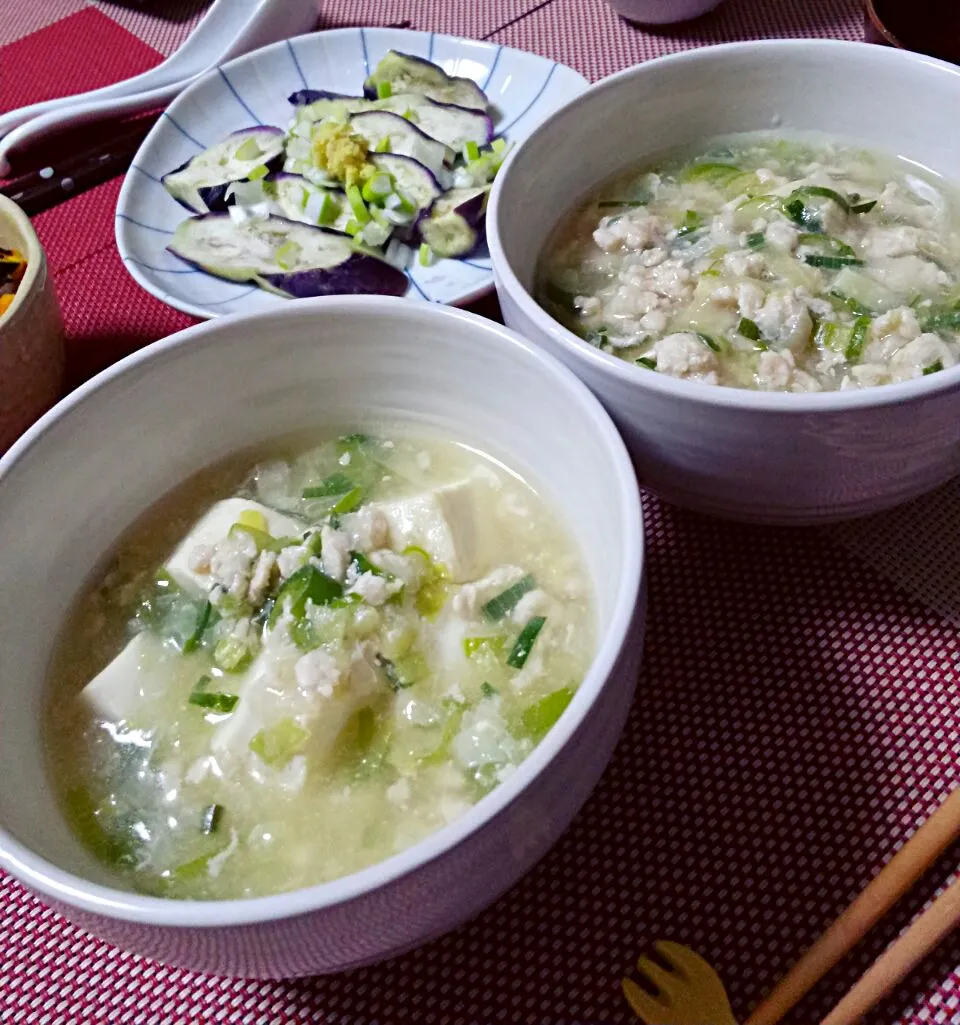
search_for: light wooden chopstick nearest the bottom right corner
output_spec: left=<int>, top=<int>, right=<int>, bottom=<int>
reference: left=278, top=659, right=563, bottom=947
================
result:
left=821, top=879, right=960, bottom=1025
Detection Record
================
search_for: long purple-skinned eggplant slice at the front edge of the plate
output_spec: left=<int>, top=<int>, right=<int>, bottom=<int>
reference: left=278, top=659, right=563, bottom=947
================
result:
left=168, top=213, right=407, bottom=299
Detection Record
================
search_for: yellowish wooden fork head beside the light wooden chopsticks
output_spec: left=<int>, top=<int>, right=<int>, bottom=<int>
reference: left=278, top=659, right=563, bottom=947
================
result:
left=623, top=940, right=737, bottom=1025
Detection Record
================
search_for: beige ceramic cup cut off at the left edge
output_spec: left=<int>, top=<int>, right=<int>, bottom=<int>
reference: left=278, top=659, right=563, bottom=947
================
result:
left=0, top=196, right=64, bottom=452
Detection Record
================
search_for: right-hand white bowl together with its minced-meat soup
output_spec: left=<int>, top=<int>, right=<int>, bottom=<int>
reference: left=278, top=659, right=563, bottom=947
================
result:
left=489, top=40, right=960, bottom=524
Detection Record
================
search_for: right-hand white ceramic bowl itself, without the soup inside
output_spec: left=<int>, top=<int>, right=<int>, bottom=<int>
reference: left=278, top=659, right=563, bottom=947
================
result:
left=488, top=39, right=960, bottom=524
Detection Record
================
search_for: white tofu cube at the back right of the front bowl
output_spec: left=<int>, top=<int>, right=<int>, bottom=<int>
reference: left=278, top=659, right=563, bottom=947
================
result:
left=376, top=477, right=497, bottom=583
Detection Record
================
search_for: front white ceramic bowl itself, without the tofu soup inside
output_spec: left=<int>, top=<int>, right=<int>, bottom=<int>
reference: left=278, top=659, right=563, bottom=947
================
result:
left=0, top=296, right=643, bottom=977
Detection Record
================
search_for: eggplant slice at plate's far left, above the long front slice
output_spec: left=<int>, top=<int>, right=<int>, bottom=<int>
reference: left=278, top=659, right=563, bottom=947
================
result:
left=161, top=125, right=284, bottom=213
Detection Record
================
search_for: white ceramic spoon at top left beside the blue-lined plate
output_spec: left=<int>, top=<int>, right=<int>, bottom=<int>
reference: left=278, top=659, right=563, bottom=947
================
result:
left=0, top=0, right=317, bottom=176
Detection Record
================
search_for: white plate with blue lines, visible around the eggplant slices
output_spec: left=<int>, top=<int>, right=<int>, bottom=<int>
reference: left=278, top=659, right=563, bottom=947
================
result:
left=116, top=29, right=588, bottom=318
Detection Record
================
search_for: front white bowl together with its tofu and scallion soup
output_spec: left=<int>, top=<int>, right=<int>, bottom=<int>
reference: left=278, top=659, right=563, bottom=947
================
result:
left=0, top=297, right=642, bottom=977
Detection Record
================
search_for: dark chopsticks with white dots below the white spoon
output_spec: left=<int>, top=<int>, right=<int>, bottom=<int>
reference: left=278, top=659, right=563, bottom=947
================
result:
left=0, top=114, right=156, bottom=216
